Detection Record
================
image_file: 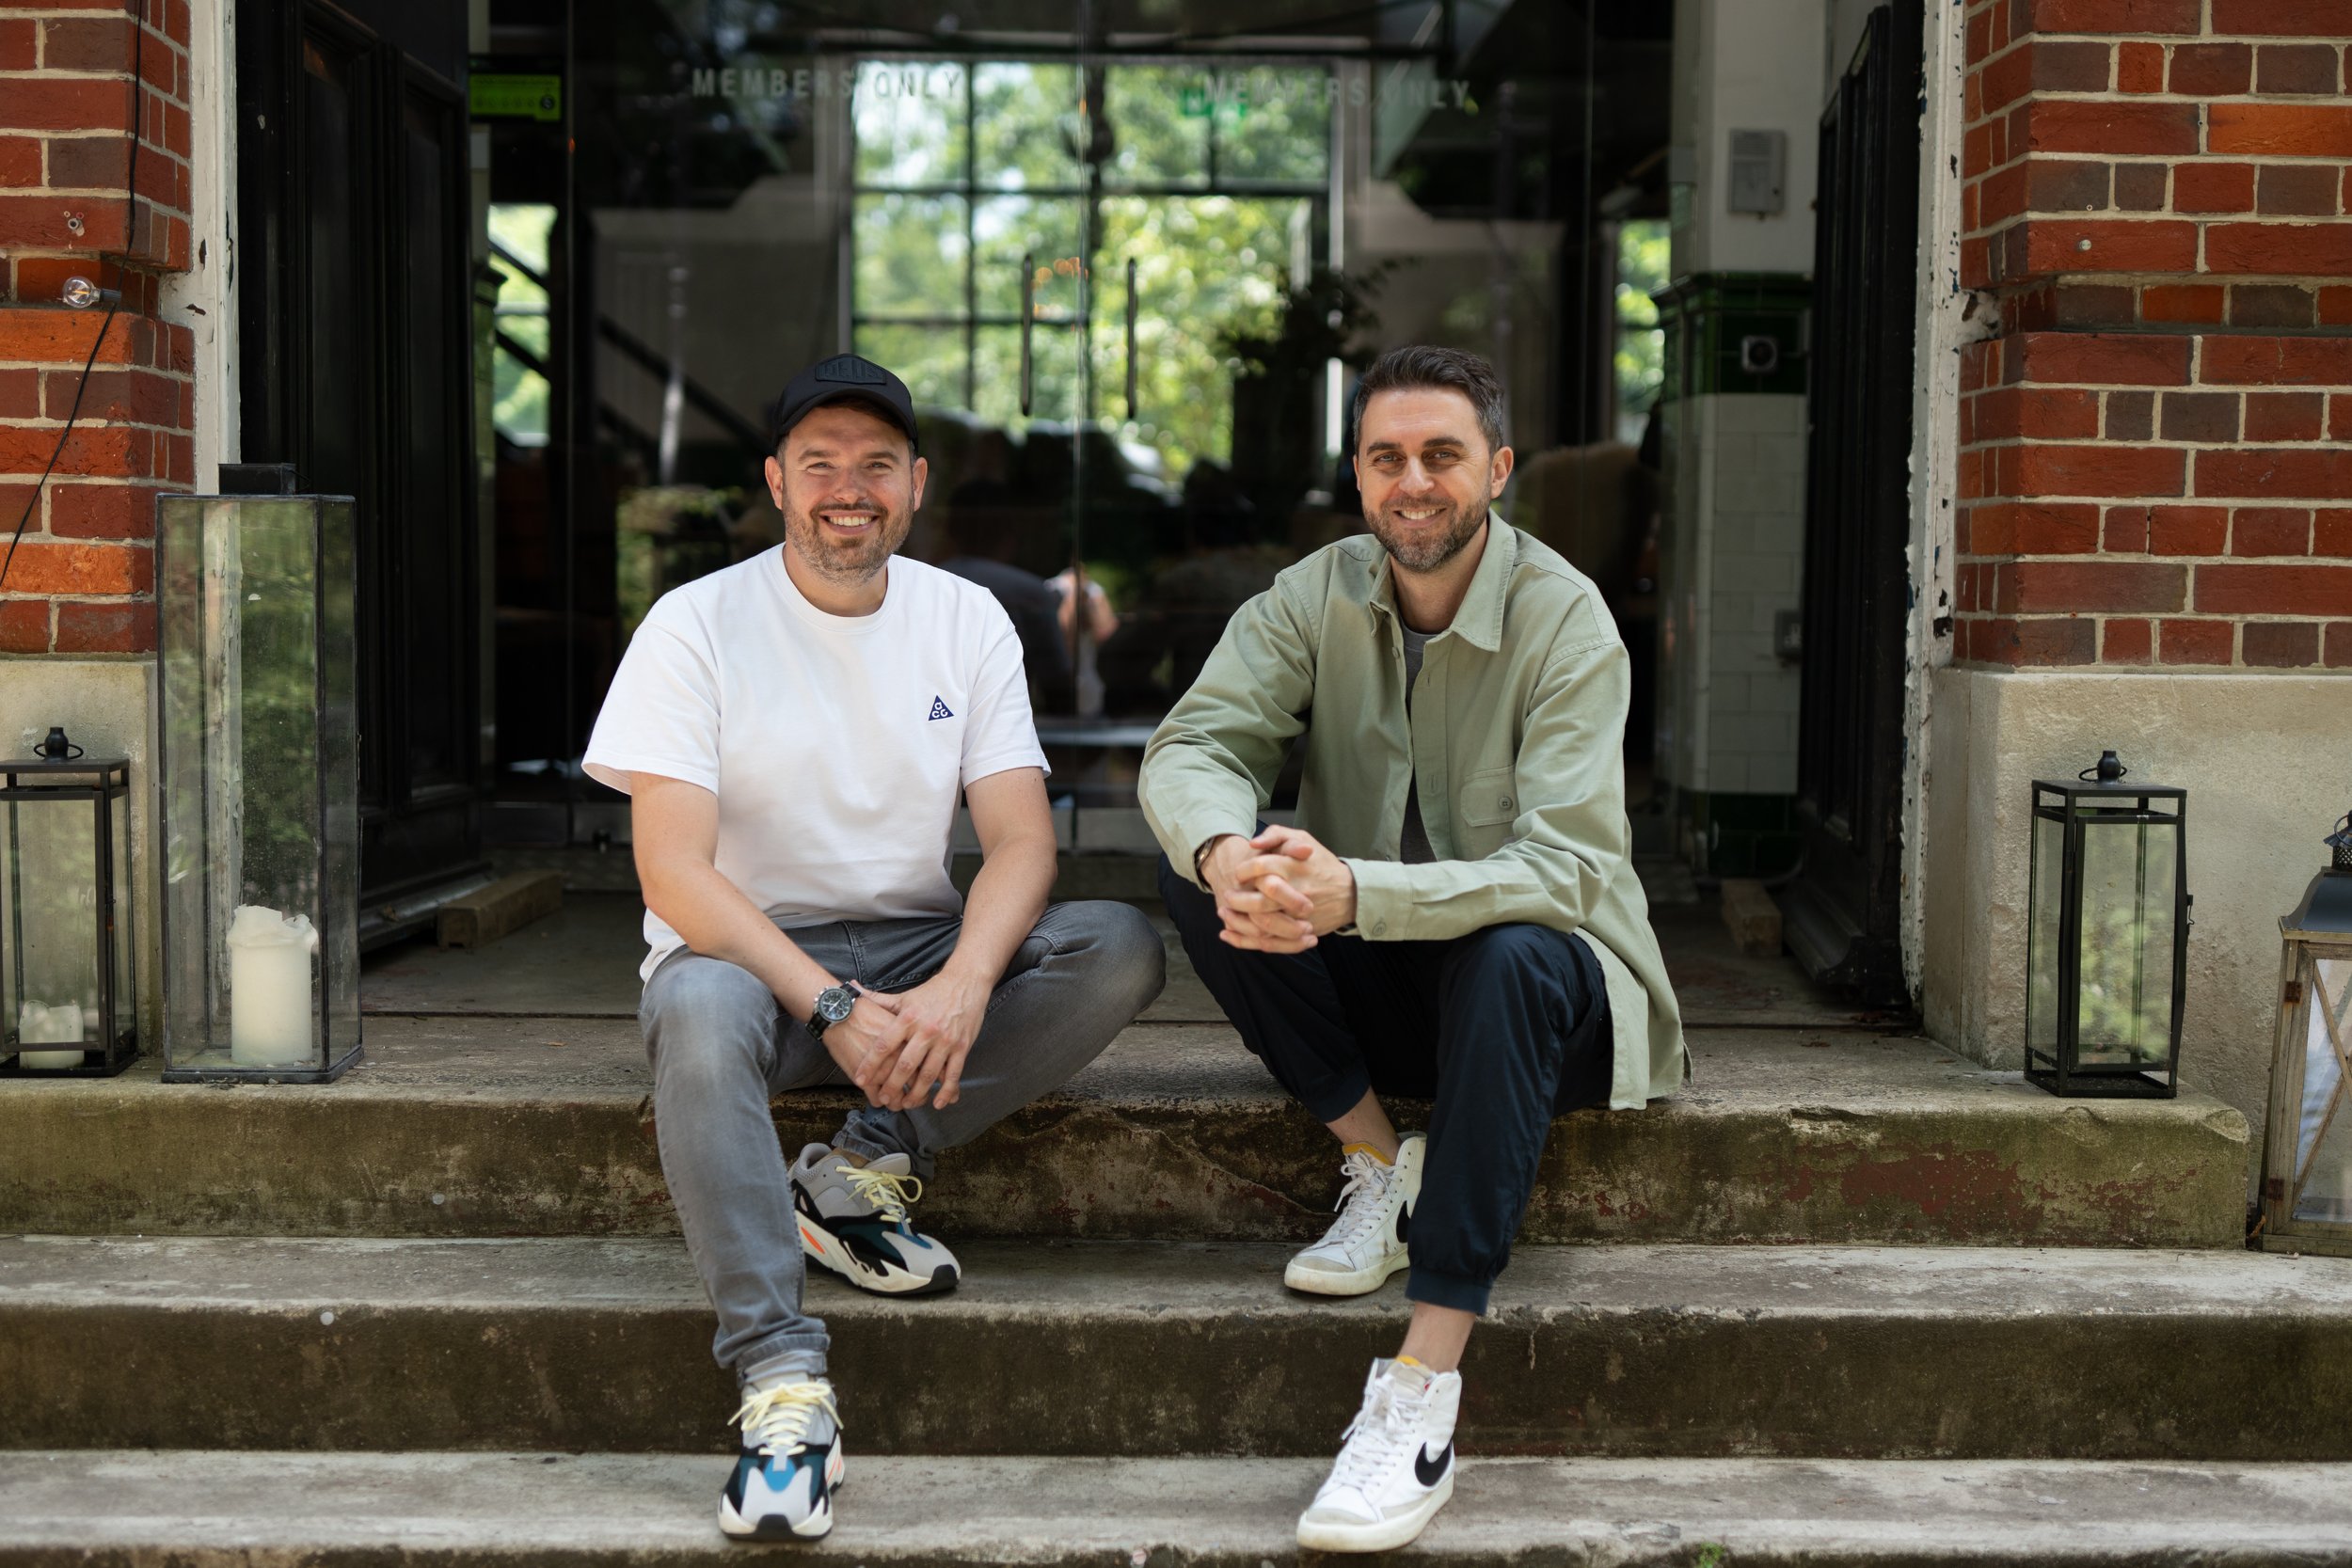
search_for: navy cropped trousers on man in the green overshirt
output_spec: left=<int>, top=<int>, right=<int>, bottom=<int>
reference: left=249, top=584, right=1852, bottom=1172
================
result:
left=1160, top=856, right=1616, bottom=1312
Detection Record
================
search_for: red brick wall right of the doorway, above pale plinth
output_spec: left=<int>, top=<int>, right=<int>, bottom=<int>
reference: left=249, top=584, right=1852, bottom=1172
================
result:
left=1955, top=0, right=2352, bottom=668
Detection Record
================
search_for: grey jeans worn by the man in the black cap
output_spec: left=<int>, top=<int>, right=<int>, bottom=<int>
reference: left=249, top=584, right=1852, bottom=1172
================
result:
left=638, top=903, right=1167, bottom=1375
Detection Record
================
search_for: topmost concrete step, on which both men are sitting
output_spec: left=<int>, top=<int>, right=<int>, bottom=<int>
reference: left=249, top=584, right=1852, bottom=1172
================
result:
left=0, top=1020, right=2249, bottom=1246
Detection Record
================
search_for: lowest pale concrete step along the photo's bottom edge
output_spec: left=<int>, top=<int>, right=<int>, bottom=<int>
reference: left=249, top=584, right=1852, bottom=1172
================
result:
left=0, top=1457, right=2352, bottom=1568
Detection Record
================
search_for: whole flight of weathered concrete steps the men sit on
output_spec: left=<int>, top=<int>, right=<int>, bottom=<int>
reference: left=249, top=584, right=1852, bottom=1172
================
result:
left=0, top=888, right=2352, bottom=1568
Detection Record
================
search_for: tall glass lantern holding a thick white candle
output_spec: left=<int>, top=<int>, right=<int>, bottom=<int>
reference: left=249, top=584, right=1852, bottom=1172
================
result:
left=155, top=496, right=360, bottom=1084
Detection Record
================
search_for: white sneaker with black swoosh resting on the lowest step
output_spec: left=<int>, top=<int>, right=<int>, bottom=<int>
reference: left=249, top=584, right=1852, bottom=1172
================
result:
left=1298, top=1361, right=1463, bottom=1552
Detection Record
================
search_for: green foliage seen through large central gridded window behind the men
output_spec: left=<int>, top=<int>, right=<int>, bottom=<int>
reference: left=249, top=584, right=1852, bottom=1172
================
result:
left=854, top=61, right=1331, bottom=477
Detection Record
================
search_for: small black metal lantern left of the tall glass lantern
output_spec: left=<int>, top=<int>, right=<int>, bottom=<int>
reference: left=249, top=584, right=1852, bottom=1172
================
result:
left=0, top=729, right=139, bottom=1077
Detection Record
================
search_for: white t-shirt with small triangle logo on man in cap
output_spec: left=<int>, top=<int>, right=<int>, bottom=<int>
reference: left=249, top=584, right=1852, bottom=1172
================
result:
left=586, top=546, right=1044, bottom=978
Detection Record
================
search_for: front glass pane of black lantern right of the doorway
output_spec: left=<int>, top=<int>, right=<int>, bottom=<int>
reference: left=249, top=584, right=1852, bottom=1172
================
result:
left=2074, top=816, right=2178, bottom=1072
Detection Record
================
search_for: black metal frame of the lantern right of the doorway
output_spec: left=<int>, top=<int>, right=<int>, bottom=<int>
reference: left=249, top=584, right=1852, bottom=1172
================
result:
left=2026, top=778, right=2192, bottom=1101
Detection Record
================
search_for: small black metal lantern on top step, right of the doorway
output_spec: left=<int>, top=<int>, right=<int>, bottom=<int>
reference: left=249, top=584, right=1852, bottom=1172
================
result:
left=2026, top=752, right=2190, bottom=1101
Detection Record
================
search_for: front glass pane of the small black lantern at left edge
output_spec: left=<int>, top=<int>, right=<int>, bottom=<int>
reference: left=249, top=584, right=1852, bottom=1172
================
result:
left=0, top=800, right=99, bottom=1068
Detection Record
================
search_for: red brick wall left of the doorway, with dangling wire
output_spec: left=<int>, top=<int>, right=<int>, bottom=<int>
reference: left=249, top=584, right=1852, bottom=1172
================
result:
left=0, top=0, right=196, bottom=654
